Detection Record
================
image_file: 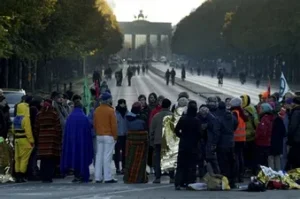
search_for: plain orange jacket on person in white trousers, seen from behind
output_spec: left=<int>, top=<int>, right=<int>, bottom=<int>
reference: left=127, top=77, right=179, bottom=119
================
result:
left=94, top=104, right=118, bottom=140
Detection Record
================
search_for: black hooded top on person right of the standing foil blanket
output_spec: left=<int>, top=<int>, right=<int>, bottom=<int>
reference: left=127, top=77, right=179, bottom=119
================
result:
left=175, top=101, right=201, bottom=153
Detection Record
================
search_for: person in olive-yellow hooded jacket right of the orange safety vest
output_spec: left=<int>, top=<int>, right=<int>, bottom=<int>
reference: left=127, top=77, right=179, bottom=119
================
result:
left=240, top=95, right=259, bottom=175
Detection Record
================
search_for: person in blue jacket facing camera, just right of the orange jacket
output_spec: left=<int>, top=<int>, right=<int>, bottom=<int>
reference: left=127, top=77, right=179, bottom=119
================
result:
left=114, top=99, right=128, bottom=174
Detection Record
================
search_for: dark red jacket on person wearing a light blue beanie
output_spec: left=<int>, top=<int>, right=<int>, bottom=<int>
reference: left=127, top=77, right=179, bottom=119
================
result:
left=255, top=113, right=274, bottom=146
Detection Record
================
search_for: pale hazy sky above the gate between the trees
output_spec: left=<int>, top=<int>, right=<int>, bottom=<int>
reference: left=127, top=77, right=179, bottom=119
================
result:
left=107, top=0, right=205, bottom=25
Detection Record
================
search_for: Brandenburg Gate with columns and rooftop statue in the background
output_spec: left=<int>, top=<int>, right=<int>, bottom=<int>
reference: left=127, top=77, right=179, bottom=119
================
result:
left=119, top=10, right=172, bottom=60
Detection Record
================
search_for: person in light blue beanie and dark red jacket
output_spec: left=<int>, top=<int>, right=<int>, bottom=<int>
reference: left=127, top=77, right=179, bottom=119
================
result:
left=255, top=103, right=274, bottom=171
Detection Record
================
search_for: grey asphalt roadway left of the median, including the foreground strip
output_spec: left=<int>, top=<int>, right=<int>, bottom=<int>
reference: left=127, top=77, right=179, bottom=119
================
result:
left=0, top=66, right=300, bottom=199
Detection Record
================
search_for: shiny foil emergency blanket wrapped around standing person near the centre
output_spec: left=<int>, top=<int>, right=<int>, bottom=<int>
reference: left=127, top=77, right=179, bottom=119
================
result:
left=161, top=107, right=185, bottom=172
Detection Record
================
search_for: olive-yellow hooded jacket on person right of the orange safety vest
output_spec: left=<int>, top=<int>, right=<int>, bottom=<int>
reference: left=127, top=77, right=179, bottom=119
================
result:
left=241, top=95, right=259, bottom=142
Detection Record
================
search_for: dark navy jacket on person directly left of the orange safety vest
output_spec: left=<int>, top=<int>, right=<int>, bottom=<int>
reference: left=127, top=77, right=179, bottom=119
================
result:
left=218, top=102, right=238, bottom=148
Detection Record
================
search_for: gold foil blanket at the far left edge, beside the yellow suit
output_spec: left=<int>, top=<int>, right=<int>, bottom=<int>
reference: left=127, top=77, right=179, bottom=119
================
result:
left=0, top=137, right=14, bottom=183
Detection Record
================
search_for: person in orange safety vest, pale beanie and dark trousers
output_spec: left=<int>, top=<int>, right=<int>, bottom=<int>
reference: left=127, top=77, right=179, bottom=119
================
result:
left=230, top=98, right=248, bottom=182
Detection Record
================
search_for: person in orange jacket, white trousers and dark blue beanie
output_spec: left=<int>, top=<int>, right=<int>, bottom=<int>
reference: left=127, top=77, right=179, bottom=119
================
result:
left=94, top=92, right=118, bottom=183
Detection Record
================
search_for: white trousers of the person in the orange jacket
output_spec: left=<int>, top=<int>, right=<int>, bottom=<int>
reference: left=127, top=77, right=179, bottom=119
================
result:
left=95, top=136, right=115, bottom=181
